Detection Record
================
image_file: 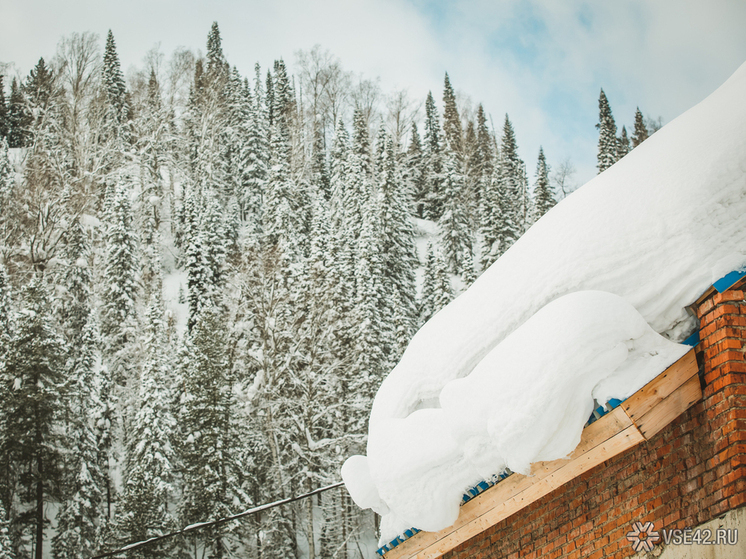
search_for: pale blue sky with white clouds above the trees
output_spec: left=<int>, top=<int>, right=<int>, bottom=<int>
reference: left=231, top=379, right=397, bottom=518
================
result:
left=0, top=0, right=746, bottom=188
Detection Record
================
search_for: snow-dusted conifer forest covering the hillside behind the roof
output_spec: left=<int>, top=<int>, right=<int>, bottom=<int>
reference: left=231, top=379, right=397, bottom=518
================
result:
left=0, top=24, right=654, bottom=559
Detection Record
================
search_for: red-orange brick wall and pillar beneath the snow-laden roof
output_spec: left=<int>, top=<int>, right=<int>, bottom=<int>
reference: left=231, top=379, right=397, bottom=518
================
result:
left=444, top=282, right=746, bottom=559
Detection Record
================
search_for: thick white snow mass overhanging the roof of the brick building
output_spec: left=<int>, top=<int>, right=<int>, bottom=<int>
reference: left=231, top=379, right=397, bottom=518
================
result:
left=343, top=60, right=746, bottom=540
